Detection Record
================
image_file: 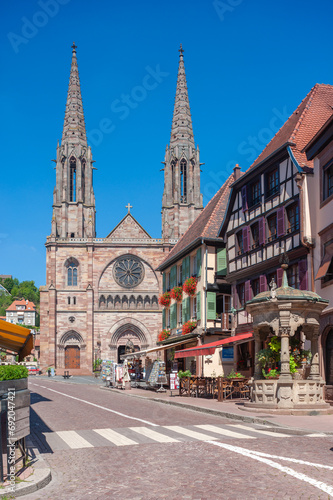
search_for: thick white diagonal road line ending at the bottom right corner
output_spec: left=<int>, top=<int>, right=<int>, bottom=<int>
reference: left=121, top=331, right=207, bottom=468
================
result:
left=207, top=441, right=333, bottom=496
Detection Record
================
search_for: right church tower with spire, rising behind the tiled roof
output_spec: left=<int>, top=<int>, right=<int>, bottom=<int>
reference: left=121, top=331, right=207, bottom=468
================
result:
left=162, top=46, right=203, bottom=239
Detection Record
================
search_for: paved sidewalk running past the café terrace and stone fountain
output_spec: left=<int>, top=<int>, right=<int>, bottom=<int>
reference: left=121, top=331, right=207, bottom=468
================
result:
left=100, top=386, right=333, bottom=435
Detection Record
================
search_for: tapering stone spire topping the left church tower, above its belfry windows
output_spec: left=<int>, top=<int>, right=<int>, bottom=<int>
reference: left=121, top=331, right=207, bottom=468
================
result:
left=61, top=43, right=87, bottom=146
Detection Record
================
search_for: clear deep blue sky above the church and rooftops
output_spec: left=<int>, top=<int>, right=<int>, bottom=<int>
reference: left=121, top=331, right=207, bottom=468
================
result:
left=0, top=0, right=333, bottom=286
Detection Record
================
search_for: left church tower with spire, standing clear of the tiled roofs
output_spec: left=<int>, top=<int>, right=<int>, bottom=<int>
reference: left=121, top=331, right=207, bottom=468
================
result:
left=51, top=43, right=96, bottom=238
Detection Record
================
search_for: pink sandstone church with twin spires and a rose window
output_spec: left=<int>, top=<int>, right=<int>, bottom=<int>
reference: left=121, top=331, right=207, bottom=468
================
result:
left=40, top=44, right=203, bottom=374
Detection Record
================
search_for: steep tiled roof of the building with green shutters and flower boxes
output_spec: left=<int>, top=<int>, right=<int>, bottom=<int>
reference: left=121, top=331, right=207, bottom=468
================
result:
left=158, top=174, right=235, bottom=268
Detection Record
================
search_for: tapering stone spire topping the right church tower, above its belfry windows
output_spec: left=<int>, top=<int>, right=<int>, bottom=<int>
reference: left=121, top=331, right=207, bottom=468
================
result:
left=170, top=45, right=194, bottom=148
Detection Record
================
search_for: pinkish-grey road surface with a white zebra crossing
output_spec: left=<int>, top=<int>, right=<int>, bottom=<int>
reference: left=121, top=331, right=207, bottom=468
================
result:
left=24, top=378, right=333, bottom=500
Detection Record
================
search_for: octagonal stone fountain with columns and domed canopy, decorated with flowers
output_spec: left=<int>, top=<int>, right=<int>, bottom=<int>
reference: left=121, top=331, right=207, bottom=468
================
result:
left=244, top=264, right=330, bottom=414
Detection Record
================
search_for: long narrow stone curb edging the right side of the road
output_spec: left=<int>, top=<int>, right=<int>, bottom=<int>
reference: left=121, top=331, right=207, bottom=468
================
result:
left=99, top=386, right=333, bottom=436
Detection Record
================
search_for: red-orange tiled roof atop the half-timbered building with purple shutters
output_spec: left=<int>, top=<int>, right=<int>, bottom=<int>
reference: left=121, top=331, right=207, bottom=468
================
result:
left=250, top=83, right=333, bottom=169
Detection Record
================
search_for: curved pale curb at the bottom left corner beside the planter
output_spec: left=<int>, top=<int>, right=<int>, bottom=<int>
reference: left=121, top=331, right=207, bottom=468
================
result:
left=0, top=437, right=52, bottom=498
